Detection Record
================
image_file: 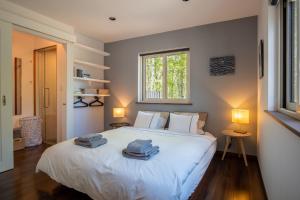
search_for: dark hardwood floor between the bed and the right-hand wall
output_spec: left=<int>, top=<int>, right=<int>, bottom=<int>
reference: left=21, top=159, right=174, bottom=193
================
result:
left=190, top=152, right=267, bottom=200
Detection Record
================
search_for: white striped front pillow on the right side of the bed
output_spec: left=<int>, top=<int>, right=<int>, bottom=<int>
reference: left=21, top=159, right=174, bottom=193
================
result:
left=169, top=113, right=199, bottom=133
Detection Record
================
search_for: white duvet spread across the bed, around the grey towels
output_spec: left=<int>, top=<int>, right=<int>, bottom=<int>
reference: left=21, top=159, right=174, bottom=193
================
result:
left=36, top=127, right=216, bottom=200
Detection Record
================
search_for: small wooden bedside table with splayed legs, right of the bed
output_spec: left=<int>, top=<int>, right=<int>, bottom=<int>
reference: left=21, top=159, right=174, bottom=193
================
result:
left=222, top=130, right=251, bottom=166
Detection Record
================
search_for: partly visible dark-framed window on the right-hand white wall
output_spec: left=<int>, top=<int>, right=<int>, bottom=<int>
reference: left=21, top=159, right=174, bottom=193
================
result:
left=281, top=0, right=300, bottom=111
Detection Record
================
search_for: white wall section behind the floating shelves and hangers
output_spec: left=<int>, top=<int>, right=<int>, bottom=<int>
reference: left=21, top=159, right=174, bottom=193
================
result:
left=74, top=33, right=104, bottom=136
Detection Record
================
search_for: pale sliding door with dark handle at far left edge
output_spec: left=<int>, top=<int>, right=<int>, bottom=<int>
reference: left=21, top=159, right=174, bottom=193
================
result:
left=0, top=20, right=13, bottom=172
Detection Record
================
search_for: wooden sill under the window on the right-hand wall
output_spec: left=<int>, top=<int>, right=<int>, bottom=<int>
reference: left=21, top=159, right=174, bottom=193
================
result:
left=265, top=110, right=300, bottom=137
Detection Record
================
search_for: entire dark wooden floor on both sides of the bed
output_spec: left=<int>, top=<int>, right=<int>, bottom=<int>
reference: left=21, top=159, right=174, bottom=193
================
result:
left=0, top=145, right=266, bottom=200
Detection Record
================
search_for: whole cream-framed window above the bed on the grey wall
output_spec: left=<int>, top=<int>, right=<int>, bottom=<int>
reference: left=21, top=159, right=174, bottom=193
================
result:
left=139, top=48, right=190, bottom=103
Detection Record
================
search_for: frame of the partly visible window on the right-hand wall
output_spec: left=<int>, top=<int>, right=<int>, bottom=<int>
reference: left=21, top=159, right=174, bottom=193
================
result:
left=279, top=0, right=300, bottom=113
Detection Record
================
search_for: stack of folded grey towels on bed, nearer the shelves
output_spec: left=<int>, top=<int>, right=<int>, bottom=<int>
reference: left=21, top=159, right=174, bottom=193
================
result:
left=74, top=133, right=107, bottom=148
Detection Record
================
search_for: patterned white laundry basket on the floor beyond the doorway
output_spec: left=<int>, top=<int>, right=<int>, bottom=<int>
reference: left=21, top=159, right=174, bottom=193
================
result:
left=20, top=117, right=42, bottom=147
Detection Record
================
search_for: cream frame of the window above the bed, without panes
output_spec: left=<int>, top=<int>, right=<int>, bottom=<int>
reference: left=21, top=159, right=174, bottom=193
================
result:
left=138, top=48, right=191, bottom=104
